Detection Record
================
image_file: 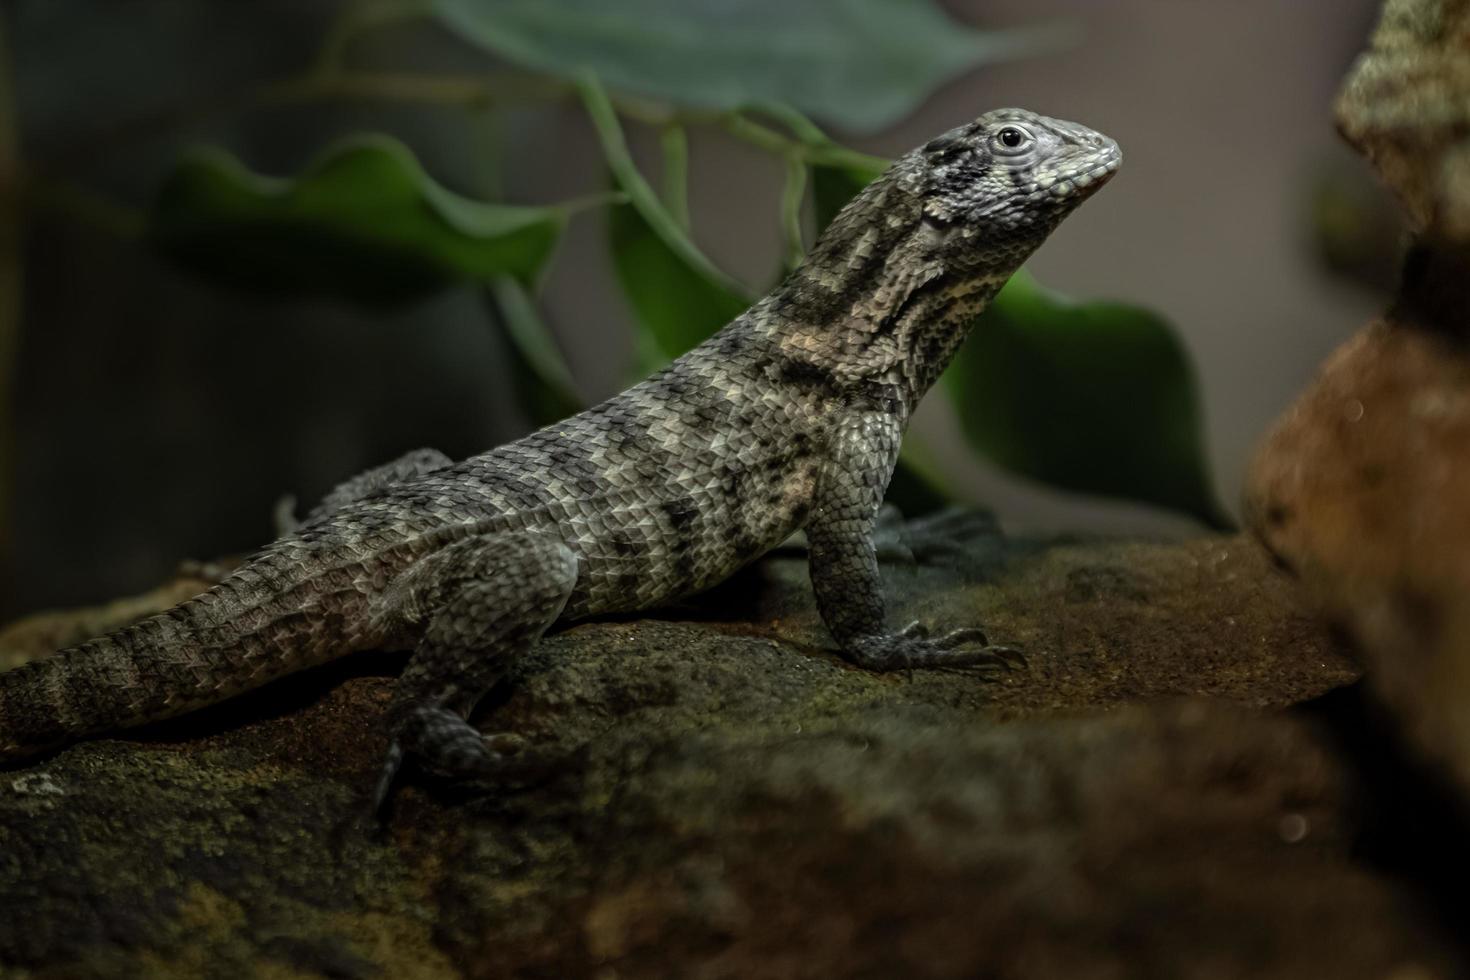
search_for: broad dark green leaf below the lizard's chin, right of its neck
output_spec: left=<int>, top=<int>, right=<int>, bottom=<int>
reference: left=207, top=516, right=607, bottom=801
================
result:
left=944, top=272, right=1232, bottom=527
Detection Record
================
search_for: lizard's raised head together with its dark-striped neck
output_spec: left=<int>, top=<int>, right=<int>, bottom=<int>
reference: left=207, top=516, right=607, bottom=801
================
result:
left=751, top=109, right=1123, bottom=403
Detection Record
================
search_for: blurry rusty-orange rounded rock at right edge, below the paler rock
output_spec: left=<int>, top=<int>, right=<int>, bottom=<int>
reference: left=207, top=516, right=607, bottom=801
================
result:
left=1247, top=310, right=1470, bottom=793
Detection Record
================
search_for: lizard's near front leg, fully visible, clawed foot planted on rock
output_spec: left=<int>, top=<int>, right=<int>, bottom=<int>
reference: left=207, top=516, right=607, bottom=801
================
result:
left=807, top=408, right=1020, bottom=670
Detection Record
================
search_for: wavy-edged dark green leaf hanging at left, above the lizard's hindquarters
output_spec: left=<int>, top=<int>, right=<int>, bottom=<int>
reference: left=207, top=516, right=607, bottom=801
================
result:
left=148, top=135, right=570, bottom=304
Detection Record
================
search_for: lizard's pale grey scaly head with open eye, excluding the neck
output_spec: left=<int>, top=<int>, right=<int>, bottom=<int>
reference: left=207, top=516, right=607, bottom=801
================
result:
left=894, top=109, right=1123, bottom=257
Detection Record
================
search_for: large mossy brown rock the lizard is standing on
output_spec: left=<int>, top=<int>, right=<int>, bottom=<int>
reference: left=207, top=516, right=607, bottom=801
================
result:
left=0, top=538, right=1464, bottom=977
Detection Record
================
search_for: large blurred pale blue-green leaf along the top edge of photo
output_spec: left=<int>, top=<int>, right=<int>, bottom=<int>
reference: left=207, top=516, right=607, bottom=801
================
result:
left=431, top=0, right=1058, bottom=132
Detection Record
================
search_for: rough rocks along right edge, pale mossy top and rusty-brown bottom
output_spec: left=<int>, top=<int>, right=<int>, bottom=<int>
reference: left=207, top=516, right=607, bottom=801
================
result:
left=1245, top=0, right=1470, bottom=816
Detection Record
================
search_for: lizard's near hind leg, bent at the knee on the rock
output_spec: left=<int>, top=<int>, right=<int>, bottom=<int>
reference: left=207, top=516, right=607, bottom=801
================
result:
left=373, top=532, right=578, bottom=813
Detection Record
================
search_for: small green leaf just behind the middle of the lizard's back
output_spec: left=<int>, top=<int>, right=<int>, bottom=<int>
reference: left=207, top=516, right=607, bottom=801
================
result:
left=607, top=204, right=750, bottom=367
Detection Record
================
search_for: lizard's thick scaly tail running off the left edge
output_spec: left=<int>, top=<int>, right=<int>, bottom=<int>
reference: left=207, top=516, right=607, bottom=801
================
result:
left=0, top=558, right=367, bottom=760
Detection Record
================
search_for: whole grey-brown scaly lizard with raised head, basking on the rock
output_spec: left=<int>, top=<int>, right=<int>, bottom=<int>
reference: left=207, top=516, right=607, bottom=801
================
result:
left=0, top=109, right=1122, bottom=807
